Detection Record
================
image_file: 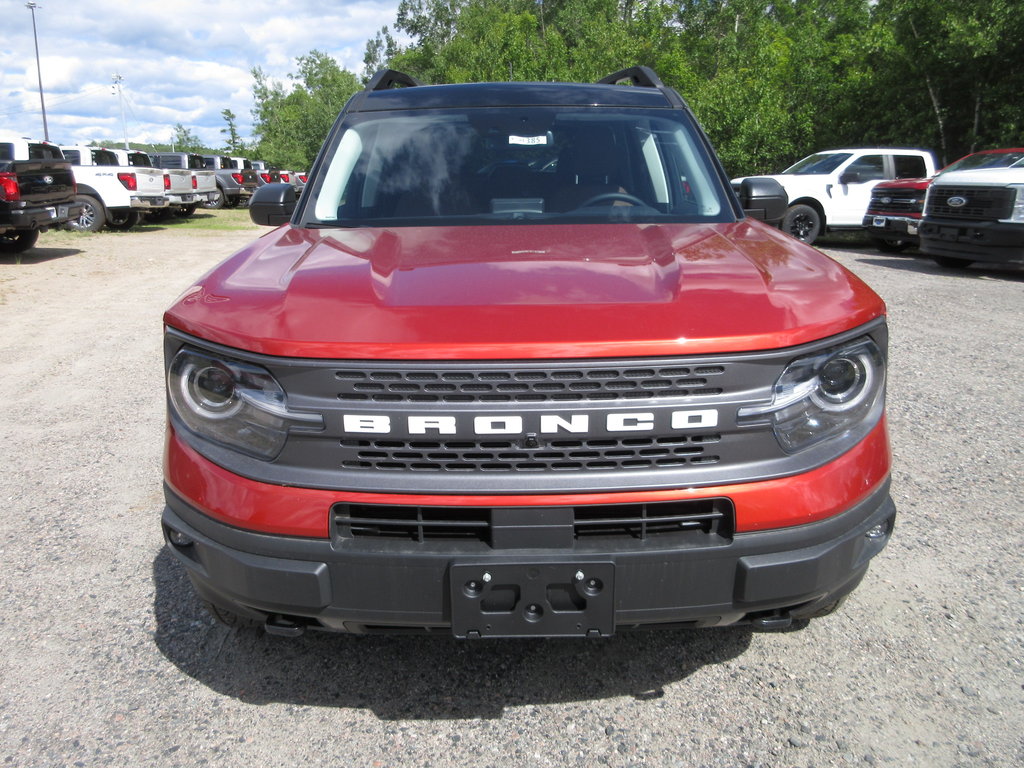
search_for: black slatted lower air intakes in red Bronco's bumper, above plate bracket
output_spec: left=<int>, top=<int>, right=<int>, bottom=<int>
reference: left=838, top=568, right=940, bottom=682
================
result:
left=332, top=499, right=735, bottom=546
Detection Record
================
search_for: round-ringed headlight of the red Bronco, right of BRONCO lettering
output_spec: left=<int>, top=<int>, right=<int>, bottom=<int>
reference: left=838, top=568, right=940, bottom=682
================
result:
left=737, top=338, right=885, bottom=454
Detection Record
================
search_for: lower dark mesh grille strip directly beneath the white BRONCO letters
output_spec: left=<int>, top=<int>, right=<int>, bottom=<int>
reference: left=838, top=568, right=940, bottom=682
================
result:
left=341, top=434, right=722, bottom=472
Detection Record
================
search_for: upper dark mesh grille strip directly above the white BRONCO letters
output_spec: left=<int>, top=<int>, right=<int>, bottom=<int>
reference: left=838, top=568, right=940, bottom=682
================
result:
left=335, top=364, right=725, bottom=402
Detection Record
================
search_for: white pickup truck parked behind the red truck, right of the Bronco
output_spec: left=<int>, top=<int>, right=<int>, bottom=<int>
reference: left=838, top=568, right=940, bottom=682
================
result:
left=732, top=147, right=936, bottom=244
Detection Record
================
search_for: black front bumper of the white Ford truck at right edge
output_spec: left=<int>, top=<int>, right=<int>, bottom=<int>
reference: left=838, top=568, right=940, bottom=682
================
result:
left=921, top=219, right=1024, bottom=264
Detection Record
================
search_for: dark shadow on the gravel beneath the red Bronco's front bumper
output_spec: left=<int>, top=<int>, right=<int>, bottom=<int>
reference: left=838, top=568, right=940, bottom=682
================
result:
left=153, top=547, right=752, bottom=720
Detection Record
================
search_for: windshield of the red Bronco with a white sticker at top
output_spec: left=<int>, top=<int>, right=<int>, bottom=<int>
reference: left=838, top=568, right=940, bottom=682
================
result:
left=304, top=108, right=733, bottom=226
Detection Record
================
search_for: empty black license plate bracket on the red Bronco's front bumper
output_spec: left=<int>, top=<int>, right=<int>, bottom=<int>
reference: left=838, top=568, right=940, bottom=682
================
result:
left=449, top=562, right=615, bottom=638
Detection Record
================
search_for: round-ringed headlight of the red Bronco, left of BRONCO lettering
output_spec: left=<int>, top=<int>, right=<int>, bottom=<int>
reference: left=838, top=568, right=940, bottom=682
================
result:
left=167, top=347, right=324, bottom=459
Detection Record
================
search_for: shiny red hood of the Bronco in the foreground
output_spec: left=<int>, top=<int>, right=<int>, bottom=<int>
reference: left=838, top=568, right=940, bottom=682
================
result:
left=165, top=220, right=885, bottom=359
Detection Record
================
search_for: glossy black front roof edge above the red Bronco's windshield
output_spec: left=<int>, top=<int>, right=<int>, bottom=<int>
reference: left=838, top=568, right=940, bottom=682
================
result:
left=349, top=83, right=675, bottom=112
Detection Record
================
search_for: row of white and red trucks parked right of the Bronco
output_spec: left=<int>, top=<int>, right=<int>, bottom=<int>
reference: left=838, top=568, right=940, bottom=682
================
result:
left=733, top=147, right=1024, bottom=267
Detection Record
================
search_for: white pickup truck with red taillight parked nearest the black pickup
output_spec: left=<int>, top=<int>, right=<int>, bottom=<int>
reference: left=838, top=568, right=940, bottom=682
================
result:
left=60, top=145, right=168, bottom=232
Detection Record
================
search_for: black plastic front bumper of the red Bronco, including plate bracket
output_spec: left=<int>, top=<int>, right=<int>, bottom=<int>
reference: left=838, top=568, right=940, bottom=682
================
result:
left=163, top=482, right=896, bottom=637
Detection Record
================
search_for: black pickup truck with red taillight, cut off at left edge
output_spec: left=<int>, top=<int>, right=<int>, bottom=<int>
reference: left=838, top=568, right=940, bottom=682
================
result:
left=0, top=136, right=82, bottom=254
